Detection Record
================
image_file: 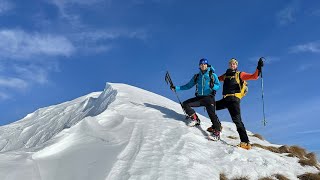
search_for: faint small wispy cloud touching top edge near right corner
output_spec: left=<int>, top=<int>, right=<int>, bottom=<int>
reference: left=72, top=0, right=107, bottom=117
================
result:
left=276, top=0, right=299, bottom=25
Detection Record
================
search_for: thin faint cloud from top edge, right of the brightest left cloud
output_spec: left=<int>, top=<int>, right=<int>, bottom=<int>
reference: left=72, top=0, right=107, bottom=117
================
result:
left=48, top=0, right=148, bottom=53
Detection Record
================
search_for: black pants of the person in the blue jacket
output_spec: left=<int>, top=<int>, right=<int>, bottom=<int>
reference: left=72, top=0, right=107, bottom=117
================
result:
left=182, top=95, right=221, bottom=131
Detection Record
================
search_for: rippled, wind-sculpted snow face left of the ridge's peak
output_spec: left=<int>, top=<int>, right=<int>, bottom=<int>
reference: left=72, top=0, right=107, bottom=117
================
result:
left=0, top=84, right=117, bottom=152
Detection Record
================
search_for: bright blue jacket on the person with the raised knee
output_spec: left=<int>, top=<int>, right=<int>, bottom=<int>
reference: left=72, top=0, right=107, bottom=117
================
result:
left=176, top=66, right=220, bottom=96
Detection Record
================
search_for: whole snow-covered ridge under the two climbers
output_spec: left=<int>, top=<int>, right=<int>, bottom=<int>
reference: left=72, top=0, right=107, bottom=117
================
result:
left=0, top=83, right=320, bottom=180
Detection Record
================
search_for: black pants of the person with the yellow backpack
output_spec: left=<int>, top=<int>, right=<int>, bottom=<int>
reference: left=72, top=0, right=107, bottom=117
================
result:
left=216, top=96, right=249, bottom=143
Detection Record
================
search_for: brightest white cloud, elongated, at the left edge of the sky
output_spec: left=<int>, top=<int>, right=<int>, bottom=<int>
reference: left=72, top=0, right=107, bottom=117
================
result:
left=0, top=30, right=75, bottom=59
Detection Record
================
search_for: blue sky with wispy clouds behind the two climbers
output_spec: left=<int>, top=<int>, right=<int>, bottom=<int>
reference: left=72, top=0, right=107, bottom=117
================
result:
left=0, top=0, right=320, bottom=159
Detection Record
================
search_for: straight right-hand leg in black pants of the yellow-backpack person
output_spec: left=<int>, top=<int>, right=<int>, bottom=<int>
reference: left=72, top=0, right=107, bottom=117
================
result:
left=227, top=97, right=249, bottom=143
